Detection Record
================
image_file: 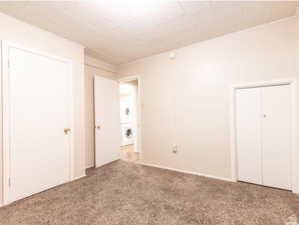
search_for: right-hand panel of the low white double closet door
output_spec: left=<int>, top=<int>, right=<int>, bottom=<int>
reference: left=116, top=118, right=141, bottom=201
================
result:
left=261, top=85, right=292, bottom=189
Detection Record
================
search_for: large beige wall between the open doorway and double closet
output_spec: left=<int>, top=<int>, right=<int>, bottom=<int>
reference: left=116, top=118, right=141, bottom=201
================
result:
left=119, top=17, right=299, bottom=178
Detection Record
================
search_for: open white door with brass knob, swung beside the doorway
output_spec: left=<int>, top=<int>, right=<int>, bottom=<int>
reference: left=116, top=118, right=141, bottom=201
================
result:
left=94, top=77, right=121, bottom=167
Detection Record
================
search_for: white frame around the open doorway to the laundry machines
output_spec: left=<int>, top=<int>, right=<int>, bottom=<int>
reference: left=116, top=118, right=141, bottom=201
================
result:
left=118, top=76, right=142, bottom=159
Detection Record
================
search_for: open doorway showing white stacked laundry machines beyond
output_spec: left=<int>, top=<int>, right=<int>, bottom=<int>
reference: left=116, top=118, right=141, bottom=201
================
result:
left=119, top=78, right=140, bottom=162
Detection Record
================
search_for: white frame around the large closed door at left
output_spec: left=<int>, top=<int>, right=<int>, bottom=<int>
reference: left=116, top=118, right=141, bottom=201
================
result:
left=0, top=40, right=74, bottom=205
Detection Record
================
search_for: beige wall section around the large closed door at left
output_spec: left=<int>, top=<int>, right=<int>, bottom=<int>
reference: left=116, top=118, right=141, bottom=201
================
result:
left=0, top=13, right=85, bottom=203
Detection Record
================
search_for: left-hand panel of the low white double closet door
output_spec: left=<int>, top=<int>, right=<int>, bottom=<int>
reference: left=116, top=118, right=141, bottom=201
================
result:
left=236, top=88, right=262, bottom=184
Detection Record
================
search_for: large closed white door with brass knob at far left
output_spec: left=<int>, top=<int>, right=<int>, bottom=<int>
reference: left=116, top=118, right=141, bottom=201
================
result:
left=4, top=47, right=71, bottom=202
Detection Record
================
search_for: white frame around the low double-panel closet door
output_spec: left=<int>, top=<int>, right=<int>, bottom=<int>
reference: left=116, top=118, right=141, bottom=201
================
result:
left=230, top=78, right=299, bottom=194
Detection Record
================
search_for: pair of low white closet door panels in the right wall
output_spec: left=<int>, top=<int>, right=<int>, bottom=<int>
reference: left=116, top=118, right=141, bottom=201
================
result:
left=236, top=85, right=292, bottom=190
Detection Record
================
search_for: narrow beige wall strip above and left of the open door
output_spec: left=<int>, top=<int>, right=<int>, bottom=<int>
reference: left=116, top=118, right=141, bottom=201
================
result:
left=85, top=56, right=116, bottom=168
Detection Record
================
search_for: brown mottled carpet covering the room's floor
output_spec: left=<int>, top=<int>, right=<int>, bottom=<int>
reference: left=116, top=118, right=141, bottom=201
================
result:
left=0, top=161, right=299, bottom=225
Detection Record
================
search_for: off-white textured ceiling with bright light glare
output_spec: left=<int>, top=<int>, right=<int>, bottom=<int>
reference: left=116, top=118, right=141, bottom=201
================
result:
left=0, top=0, right=299, bottom=64
